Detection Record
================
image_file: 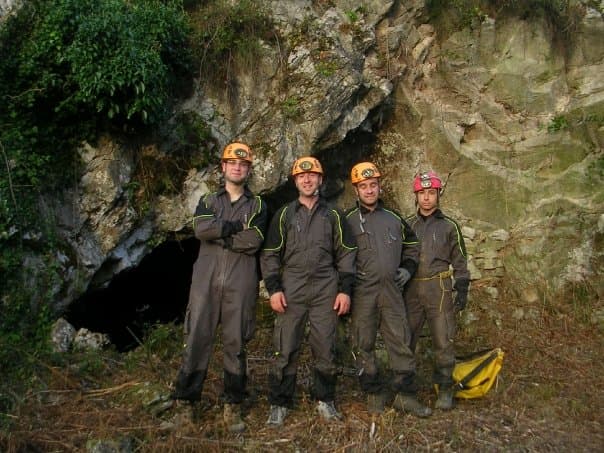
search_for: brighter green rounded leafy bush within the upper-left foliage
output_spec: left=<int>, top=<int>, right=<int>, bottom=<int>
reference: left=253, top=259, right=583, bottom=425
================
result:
left=62, top=0, right=188, bottom=124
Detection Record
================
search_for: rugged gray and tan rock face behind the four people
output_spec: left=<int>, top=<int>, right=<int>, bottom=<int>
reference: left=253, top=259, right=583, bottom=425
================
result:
left=44, top=0, right=604, bottom=307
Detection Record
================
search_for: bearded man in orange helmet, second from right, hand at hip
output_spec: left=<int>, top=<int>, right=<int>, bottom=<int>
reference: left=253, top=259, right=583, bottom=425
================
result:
left=346, top=162, right=432, bottom=417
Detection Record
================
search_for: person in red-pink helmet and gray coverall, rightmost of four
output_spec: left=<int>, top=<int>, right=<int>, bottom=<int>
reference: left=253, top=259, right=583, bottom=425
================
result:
left=405, top=171, right=470, bottom=410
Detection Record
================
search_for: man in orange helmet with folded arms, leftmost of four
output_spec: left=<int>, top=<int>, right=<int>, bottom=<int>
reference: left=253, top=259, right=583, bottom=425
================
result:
left=172, top=142, right=267, bottom=432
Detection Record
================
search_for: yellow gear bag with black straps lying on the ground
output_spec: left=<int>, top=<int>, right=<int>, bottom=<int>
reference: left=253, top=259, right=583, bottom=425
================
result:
left=438, top=348, right=504, bottom=399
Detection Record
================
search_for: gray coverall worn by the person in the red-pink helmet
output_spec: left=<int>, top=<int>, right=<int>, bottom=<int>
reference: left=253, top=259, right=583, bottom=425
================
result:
left=405, top=209, right=470, bottom=387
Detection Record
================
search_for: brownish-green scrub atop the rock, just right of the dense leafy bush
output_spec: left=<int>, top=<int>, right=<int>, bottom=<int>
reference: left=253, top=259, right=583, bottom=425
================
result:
left=191, top=0, right=275, bottom=87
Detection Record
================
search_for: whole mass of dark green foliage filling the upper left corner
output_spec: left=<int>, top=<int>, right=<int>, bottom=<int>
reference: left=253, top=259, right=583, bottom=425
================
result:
left=0, top=0, right=190, bottom=194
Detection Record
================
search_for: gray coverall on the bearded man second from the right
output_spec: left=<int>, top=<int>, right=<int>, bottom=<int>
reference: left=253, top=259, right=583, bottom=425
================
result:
left=346, top=201, right=420, bottom=394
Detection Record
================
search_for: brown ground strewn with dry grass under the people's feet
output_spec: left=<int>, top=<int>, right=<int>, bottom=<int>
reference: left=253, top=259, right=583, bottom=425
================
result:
left=0, top=292, right=604, bottom=452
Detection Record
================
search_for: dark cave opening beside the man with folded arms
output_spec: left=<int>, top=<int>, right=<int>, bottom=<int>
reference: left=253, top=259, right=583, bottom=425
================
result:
left=65, top=238, right=199, bottom=352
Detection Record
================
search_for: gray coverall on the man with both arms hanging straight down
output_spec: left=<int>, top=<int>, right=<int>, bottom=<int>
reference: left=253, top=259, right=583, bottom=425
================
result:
left=260, top=199, right=356, bottom=407
